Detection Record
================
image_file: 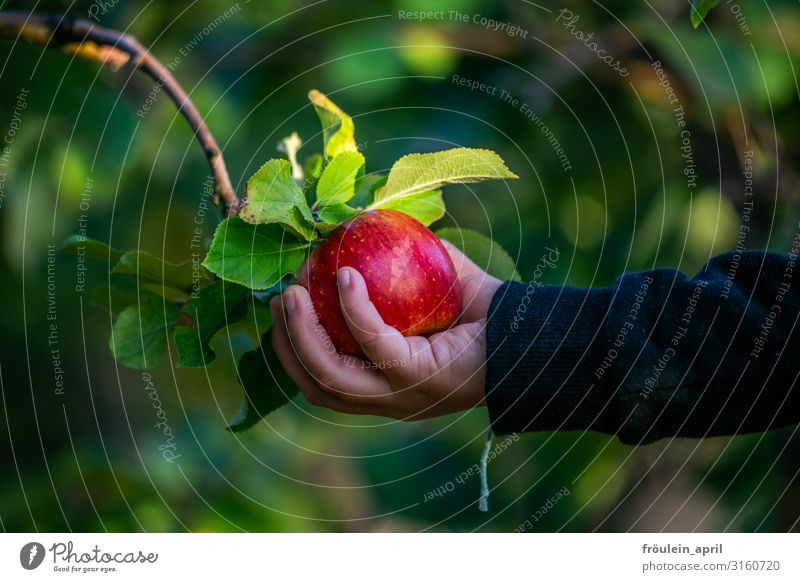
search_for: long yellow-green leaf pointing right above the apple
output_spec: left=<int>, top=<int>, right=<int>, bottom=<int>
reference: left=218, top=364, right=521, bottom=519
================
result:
left=369, top=148, right=517, bottom=217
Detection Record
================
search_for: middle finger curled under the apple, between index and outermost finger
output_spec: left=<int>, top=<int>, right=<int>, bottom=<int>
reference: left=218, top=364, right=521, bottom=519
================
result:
left=283, top=285, right=392, bottom=404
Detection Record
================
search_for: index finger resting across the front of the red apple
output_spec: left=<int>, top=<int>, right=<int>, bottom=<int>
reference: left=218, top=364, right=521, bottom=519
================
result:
left=338, top=267, right=411, bottom=373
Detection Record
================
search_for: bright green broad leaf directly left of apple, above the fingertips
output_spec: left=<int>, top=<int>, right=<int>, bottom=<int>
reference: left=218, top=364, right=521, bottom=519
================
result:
left=203, top=217, right=309, bottom=289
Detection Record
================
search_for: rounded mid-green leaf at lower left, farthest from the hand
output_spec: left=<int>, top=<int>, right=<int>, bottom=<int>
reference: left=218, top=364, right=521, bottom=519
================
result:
left=108, top=293, right=181, bottom=370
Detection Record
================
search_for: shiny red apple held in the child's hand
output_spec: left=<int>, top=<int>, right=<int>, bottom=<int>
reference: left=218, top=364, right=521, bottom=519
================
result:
left=297, top=210, right=461, bottom=357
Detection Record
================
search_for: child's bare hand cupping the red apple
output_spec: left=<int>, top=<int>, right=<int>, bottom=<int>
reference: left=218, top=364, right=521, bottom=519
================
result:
left=270, top=241, right=501, bottom=420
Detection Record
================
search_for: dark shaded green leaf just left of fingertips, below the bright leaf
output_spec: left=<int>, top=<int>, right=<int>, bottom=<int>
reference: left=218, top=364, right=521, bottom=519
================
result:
left=175, top=281, right=250, bottom=368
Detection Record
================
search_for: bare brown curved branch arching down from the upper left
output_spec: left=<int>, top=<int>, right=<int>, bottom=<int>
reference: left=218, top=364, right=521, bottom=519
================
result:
left=0, top=11, right=239, bottom=216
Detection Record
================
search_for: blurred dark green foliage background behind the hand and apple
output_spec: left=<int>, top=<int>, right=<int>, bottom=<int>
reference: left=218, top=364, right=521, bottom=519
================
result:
left=0, top=0, right=800, bottom=531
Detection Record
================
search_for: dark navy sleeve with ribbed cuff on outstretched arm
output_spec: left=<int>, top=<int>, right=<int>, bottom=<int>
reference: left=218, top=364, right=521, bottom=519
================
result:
left=486, top=249, right=800, bottom=445
